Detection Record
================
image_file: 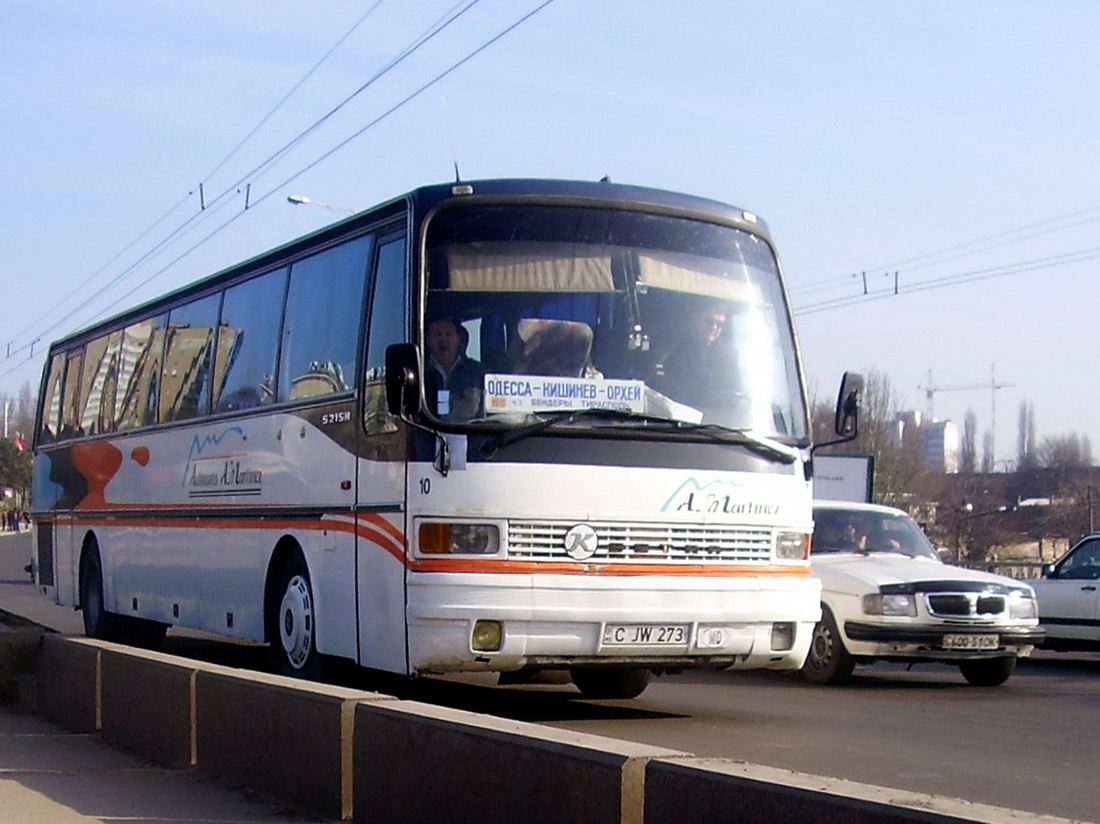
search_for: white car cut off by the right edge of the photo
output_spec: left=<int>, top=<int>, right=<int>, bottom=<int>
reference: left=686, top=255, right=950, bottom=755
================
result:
left=1032, top=535, right=1100, bottom=651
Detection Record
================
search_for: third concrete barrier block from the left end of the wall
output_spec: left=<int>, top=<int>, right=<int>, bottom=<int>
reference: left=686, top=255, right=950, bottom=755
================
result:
left=196, top=670, right=394, bottom=818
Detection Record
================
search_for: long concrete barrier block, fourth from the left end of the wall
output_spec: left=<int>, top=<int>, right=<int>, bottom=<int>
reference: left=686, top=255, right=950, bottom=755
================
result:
left=354, top=701, right=685, bottom=824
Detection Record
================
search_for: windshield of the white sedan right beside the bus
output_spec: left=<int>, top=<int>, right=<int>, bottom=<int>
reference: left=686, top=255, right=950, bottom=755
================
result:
left=813, top=508, right=939, bottom=560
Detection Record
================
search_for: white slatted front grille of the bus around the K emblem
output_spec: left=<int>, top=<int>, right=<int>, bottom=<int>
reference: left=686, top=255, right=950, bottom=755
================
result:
left=508, top=521, right=772, bottom=563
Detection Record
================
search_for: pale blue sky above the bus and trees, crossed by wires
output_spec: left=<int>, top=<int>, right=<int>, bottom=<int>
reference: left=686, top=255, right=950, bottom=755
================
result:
left=0, top=0, right=1100, bottom=459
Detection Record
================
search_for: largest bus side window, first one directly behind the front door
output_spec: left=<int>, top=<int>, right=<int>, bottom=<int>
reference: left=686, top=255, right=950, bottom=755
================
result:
left=278, top=235, right=374, bottom=400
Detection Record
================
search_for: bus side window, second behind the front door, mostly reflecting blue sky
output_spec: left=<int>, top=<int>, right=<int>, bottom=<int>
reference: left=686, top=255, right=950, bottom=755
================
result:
left=213, top=268, right=286, bottom=411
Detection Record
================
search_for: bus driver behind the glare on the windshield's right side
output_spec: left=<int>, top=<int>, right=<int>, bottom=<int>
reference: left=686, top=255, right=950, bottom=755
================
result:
left=647, top=304, right=734, bottom=408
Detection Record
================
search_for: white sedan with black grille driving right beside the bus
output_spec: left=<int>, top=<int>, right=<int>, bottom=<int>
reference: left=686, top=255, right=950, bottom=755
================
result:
left=802, top=502, right=1044, bottom=686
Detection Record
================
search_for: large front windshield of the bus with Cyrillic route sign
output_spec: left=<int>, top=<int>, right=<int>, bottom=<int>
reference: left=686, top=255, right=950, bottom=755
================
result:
left=424, top=204, right=807, bottom=442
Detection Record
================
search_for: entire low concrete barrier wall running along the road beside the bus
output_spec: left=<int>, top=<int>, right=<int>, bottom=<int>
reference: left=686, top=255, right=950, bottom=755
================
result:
left=37, top=634, right=1070, bottom=824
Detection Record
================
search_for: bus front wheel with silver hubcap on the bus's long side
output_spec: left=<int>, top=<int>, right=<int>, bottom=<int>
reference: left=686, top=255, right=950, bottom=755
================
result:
left=267, top=549, right=322, bottom=681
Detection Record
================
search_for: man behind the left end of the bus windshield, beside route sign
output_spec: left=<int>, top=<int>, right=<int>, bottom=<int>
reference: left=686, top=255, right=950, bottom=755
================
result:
left=427, top=318, right=485, bottom=420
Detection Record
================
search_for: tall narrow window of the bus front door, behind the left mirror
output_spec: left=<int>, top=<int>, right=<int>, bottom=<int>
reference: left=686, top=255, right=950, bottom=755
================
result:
left=363, top=235, right=407, bottom=435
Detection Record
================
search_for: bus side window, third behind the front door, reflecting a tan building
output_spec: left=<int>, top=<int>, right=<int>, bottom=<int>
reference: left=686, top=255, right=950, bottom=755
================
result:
left=161, top=294, right=221, bottom=421
